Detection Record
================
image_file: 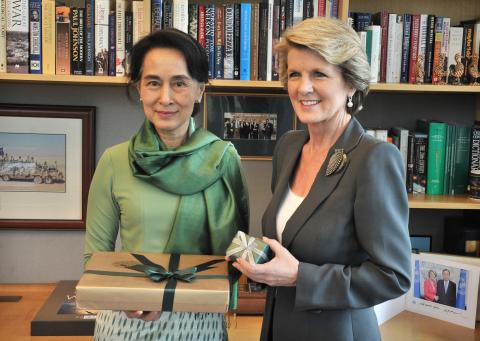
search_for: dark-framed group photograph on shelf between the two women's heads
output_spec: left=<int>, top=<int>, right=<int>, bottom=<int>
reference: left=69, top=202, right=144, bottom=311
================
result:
left=203, top=93, right=296, bottom=160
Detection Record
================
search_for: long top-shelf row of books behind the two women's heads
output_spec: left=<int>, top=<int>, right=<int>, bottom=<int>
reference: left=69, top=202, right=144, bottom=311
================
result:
left=0, top=0, right=339, bottom=77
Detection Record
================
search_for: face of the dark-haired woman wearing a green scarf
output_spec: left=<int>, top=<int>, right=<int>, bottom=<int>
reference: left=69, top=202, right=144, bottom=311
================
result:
left=137, top=48, right=204, bottom=140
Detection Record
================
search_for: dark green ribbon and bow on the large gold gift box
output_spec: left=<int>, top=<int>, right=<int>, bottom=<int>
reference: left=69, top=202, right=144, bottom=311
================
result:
left=84, top=253, right=228, bottom=311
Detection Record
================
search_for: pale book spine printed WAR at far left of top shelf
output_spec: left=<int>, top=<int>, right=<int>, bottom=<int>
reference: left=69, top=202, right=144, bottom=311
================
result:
left=6, top=0, right=29, bottom=73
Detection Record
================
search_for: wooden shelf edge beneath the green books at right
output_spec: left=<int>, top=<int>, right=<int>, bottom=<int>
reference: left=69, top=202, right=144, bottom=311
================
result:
left=408, top=194, right=480, bottom=210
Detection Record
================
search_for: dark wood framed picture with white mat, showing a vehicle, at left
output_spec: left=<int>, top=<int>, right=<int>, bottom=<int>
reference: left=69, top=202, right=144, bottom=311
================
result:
left=0, top=104, right=95, bottom=229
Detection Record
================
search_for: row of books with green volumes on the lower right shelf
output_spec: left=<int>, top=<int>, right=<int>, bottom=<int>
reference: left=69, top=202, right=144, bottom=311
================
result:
left=366, top=120, right=480, bottom=196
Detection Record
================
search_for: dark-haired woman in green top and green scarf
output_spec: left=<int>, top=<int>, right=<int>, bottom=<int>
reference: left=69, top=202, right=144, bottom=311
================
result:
left=84, top=29, right=249, bottom=340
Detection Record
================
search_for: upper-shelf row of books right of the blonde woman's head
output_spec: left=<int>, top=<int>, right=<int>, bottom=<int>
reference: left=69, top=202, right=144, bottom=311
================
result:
left=349, top=11, right=480, bottom=85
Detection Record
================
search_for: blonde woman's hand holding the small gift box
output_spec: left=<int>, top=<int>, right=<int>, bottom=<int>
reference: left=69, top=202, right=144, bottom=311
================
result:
left=232, top=237, right=299, bottom=287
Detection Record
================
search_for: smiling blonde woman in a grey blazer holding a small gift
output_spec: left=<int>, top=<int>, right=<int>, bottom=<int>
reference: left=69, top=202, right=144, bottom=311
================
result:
left=234, top=18, right=411, bottom=341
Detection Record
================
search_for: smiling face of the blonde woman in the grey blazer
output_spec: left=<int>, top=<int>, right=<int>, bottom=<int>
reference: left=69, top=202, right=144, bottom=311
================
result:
left=287, top=47, right=354, bottom=124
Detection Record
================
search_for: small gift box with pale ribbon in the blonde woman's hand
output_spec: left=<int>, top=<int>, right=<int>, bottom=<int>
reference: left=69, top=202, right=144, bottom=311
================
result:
left=227, top=231, right=270, bottom=265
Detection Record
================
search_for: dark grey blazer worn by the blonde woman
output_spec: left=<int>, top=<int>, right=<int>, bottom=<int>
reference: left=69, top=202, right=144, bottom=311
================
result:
left=261, top=118, right=411, bottom=341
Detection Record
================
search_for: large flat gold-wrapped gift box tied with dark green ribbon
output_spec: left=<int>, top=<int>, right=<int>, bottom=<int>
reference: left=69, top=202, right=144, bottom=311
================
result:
left=77, top=252, right=230, bottom=313
